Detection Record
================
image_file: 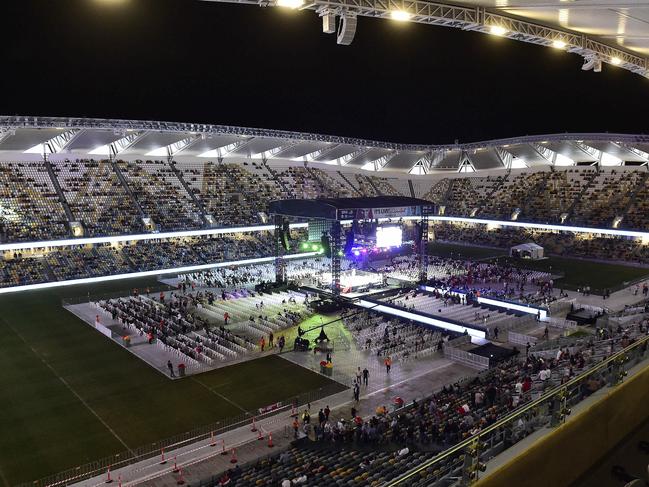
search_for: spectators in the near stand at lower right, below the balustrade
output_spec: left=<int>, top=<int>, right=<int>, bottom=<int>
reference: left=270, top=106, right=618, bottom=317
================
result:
left=210, top=320, right=649, bottom=487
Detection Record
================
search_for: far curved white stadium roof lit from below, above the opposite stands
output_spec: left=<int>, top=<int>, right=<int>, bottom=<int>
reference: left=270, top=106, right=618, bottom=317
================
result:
left=0, top=116, right=649, bottom=175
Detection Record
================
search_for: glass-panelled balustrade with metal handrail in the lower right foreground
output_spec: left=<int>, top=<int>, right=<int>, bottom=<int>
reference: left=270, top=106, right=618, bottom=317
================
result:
left=386, top=336, right=649, bottom=487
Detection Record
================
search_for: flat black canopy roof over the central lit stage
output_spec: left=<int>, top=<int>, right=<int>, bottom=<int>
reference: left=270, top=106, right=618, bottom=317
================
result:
left=268, top=196, right=434, bottom=220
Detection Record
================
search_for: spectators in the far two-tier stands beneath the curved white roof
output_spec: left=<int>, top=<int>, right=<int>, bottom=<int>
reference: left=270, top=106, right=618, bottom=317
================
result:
left=0, top=159, right=649, bottom=287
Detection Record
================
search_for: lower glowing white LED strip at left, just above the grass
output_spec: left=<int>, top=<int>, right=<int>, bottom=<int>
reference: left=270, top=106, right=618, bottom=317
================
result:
left=0, top=252, right=319, bottom=294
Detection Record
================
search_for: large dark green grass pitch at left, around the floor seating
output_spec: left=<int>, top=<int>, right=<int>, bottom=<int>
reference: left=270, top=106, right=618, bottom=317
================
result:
left=0, top=280, right=343, bottom=486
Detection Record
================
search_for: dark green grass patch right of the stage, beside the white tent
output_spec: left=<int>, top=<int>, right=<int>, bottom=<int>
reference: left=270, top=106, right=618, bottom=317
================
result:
left=492, top=257, right=649, bottom=293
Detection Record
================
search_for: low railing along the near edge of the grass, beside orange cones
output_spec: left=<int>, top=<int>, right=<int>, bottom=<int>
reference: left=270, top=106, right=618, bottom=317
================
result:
left=17, top=383, right=341, bottom=487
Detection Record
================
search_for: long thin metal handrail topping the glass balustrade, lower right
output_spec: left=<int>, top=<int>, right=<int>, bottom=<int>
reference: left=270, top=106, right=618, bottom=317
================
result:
left=387, top=336, right=649, bottom=487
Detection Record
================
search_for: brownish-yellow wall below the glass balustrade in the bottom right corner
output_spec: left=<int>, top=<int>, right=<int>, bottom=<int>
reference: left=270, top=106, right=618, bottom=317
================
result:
left=476, top=363, right=649, bottom=487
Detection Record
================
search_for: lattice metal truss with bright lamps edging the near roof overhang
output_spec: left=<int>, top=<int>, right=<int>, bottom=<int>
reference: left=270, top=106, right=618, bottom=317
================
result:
left=203, top=0, right=649, bottom=78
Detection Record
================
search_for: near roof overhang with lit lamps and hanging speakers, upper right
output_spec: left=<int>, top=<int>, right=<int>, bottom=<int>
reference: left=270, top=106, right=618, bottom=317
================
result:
left=205, top=0, right=649, bottom=77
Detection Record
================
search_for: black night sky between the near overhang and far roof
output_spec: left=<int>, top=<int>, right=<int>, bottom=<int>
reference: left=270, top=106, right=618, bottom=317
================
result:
left=0, top=0, right=649, bottom=143
